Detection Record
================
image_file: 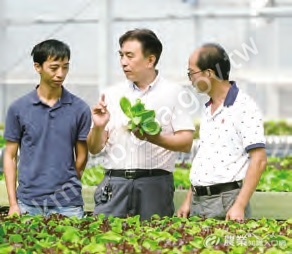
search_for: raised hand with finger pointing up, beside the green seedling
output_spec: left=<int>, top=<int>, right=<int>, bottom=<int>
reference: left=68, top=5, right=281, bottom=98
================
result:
left=91, top=94, right=110, bottom=128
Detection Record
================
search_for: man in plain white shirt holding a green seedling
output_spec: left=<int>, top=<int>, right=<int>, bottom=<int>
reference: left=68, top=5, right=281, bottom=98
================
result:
left=87, top=29, right=194, bottom=220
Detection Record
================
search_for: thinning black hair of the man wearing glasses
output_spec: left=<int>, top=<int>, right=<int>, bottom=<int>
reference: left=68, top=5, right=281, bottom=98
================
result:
left=197, top=43, right=230, bottom=80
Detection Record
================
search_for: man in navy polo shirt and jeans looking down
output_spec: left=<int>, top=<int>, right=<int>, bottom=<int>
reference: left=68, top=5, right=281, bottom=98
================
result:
left=4, top=39, right=91, bottom=218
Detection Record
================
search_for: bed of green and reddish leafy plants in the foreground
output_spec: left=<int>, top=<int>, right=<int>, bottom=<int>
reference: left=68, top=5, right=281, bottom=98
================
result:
left=0, top=214, right=292, bottom=254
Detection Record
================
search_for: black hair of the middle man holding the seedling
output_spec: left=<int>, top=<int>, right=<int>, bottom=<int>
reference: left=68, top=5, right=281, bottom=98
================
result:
left=119, top=28, right=162, bottom=66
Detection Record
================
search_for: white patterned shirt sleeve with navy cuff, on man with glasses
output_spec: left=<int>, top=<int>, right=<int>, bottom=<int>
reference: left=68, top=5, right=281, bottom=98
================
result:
left=237, top=97, right=266, bottom=152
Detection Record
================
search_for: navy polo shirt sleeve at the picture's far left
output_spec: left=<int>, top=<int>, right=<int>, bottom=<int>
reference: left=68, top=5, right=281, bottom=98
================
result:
left=4, top=104, right=22, bottom=142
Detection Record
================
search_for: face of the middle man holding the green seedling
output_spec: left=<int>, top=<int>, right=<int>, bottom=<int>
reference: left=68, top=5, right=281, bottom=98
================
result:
left=119, top=40, right=153, bottom=82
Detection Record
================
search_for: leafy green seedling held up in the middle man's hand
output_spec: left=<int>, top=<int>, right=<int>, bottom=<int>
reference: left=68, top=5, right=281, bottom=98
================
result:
left=120, top=97, right=161, bottom=135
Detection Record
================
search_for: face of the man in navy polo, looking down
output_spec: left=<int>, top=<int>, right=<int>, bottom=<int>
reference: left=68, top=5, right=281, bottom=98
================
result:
left=35, top=57, right=69, bottom=88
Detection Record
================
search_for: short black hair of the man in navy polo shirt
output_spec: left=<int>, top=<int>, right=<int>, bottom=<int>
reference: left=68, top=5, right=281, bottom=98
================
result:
left=31, top=39, right=70, bottom=65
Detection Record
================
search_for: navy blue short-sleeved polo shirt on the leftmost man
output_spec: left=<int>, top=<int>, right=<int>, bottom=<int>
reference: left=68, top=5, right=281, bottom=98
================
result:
left=4, top=87, right=91, bottom=206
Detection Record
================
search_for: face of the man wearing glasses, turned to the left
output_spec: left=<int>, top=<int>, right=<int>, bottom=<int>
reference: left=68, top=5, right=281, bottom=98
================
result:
left=188, top=49, right=211, bottom=93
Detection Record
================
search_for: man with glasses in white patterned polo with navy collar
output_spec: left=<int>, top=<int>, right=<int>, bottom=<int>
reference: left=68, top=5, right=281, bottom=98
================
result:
left=177, top=43, right=267, bottom=220
